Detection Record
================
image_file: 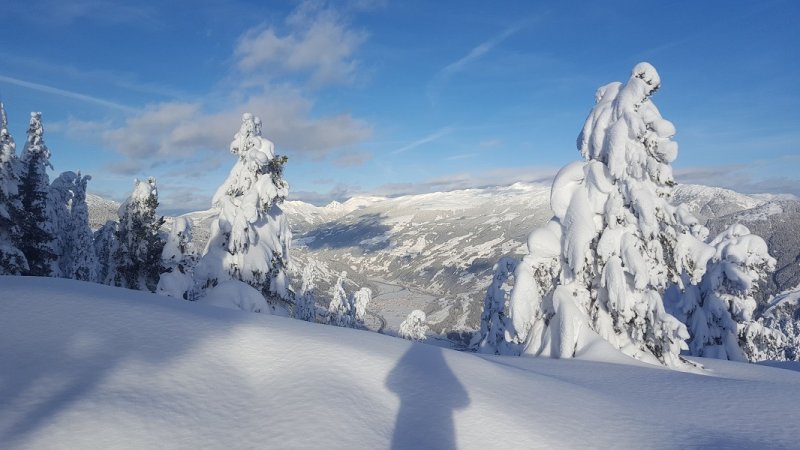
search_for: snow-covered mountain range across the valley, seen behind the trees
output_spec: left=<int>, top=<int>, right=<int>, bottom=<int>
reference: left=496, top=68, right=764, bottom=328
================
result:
left=83, top=183, right=800, bottom=341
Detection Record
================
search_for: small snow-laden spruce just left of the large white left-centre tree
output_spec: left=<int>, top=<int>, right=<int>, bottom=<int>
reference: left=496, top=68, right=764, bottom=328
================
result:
left=156, top=217, right=197, bottom=300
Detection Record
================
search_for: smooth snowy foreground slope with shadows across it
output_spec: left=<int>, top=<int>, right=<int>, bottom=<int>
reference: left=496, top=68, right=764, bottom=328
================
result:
left=0, top=277, right=800, bottom=449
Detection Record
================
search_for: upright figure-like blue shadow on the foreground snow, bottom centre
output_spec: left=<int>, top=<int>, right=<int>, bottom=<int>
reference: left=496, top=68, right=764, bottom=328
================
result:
left=386, top=344, right=469, bottom=449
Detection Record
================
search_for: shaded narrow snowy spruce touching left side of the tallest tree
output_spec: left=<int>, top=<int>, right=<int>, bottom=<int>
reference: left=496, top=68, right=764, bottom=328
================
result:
left=471, top=256, right=517, bottom=355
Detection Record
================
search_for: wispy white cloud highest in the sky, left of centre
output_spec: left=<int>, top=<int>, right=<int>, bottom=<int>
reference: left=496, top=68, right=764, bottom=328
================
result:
left=234, top=2, right=367, bottom=87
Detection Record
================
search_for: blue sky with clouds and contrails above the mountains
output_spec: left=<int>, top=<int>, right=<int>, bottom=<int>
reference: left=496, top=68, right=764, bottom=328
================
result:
left=0, top=0, right=800, bottom=212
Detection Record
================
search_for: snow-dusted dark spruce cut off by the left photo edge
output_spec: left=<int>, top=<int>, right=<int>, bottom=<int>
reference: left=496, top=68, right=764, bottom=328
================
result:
left=0, top=102, right=28, bottom=275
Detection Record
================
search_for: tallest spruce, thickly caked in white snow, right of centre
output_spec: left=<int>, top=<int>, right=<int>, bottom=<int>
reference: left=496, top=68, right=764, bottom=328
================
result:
left=496, top=63, right=714, bottom=366
